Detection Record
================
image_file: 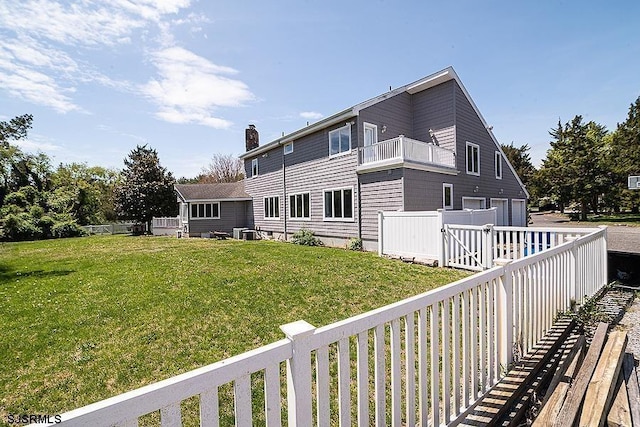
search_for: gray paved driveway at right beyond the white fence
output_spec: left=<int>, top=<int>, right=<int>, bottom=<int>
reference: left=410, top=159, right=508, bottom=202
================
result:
left=531, top=212, right=640, bottom=254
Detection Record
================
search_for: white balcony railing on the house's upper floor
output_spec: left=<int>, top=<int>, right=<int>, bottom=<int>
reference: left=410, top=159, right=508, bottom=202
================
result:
left=359, top=135, right=456, bottom=168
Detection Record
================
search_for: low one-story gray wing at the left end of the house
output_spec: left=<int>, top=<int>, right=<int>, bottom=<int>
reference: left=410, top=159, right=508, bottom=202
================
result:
left=175, top=181, right=253, bottom=237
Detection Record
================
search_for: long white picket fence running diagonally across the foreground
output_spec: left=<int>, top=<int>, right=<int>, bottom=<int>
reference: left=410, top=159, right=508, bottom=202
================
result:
left=40, top=229, right=606, bottom=427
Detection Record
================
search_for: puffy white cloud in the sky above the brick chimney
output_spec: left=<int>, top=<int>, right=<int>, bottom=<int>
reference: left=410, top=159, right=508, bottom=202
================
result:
left=140, top=47, right=255, bottom=129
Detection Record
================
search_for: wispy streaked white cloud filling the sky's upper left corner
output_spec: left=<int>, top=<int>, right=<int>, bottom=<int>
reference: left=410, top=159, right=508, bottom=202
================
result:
left=0, top=0, right=190, bottom=113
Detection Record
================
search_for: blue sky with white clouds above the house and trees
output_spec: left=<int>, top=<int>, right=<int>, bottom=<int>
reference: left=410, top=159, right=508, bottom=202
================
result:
left=0, top=0, right=640, bottom=177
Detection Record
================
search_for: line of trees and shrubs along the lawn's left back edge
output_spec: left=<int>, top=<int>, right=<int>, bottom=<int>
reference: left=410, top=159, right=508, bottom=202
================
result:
left=0, top=114, right=243, bottom=241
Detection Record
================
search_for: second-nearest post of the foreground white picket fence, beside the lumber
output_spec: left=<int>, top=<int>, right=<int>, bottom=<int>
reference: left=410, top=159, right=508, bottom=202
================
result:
left=497, top=260, right=513, bottom=372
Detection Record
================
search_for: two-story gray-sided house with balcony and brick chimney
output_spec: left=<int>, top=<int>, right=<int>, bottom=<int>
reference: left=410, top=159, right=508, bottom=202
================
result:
left=240, top=67, right=528, bottom=249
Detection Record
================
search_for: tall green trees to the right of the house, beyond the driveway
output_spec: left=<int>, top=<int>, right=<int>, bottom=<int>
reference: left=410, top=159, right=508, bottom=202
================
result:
left=502, top=97, right=640, bottom=220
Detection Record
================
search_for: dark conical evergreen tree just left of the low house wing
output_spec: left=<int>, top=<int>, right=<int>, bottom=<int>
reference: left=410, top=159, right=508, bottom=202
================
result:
left=114, top=145, right=178, bottom=230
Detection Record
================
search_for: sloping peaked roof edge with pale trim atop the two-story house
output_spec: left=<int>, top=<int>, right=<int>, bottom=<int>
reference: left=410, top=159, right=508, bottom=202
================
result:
left=240, top=66, right=529, bottom=198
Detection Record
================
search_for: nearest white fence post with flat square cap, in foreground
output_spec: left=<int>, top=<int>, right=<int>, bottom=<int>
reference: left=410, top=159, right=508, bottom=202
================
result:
left=280, top=320, right=316, bottom=426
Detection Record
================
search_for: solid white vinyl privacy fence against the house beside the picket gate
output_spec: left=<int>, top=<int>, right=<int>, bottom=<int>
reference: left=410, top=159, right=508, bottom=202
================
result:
left=378, top=208, right=496, bottom=265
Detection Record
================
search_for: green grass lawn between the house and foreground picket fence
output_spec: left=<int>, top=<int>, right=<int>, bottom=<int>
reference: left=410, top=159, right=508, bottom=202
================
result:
left=0, top=236, right=468, bottom=424
